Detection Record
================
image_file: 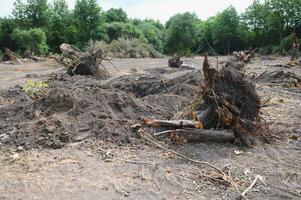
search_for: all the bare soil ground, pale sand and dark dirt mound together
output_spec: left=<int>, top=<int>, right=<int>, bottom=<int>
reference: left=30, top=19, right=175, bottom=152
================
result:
left=0, top=57, right=301, bottom=199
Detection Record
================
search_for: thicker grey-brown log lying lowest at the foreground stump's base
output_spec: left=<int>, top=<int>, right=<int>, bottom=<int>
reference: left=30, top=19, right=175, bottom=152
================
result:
left=154, top=129, right=234, bottom=142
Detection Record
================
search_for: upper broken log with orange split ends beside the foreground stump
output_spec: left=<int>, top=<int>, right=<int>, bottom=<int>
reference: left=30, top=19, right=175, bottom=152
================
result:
left=143, top=118, right=204, bottom=129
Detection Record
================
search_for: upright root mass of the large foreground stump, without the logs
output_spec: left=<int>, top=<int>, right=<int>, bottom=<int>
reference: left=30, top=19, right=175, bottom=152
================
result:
left=195, top=57, right=260, bottom=133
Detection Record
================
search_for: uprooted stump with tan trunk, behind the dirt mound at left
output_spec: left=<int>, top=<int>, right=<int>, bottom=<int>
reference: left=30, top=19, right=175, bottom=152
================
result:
left=58, top=43, right=110, bottom=79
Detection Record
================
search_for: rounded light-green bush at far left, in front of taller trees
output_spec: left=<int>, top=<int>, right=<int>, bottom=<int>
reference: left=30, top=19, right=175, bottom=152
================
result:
left=12, top=28, right=48, bottom=55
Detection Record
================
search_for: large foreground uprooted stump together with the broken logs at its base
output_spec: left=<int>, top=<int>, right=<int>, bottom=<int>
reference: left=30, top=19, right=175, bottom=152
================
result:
left=144, top=57, right=260, bottom=145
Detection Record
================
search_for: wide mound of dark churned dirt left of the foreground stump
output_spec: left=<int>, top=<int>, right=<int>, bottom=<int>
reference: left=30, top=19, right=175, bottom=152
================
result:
left=0, top=69, right=200, bottom=149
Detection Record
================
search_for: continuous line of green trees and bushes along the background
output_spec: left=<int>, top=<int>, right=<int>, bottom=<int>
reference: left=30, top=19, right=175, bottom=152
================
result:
left=0, top=0, right=301, bottom=55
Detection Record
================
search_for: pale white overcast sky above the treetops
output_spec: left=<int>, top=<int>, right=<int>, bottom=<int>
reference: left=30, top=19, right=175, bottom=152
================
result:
left=0, top=0, right=253, bottom=23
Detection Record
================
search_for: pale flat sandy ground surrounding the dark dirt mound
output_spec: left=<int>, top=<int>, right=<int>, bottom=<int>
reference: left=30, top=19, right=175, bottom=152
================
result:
left=0, top=57, right=301, bottom=199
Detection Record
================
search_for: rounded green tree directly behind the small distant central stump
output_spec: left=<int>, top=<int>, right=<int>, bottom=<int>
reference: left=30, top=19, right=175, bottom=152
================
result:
left=165, top=12, right=198, bottom=54
